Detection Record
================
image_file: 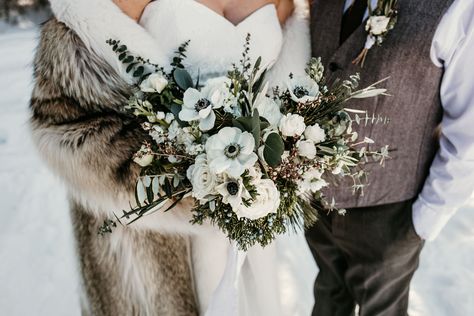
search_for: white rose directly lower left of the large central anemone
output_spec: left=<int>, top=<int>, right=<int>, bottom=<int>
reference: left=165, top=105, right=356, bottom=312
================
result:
left=186, top=154, right=219, bottom=203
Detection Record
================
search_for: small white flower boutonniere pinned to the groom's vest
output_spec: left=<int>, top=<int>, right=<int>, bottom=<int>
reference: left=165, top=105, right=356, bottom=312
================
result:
left=352, top=0, right=398, bottom=67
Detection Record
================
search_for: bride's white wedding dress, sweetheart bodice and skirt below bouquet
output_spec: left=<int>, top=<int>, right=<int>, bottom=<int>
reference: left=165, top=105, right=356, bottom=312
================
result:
left=140, top=0, right=316, bottom=316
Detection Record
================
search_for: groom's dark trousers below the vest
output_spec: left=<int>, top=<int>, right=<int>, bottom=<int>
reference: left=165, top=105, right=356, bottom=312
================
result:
left=306, top=200, right=424, bottom=316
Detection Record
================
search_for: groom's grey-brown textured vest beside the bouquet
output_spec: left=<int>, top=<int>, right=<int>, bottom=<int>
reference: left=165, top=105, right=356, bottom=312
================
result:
left=311, top=0, right=453, bottom=208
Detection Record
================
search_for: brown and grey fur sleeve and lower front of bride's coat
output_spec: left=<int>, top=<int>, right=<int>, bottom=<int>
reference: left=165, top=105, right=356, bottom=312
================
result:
left=31, top=20, right=197, bottom=315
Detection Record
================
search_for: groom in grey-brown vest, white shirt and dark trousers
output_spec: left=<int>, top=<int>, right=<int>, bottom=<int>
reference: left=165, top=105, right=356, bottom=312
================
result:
left=307, top=0, right=474, bottom=316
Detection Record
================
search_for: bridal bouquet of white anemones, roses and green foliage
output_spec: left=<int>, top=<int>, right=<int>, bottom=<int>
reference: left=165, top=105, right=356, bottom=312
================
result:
left=102, top=38, right=388, bottom=250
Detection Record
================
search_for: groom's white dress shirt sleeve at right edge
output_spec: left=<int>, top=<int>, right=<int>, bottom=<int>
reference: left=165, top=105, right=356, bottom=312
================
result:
left=345, top=0, right=474, bottom=240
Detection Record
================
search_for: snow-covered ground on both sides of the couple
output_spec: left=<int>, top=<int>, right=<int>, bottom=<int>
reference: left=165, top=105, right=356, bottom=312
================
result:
left=0, top=22, right=474, bottom=316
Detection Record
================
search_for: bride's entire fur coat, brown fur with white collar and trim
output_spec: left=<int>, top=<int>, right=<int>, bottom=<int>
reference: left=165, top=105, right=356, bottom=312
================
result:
left=31, top=0, right=310, bottom=315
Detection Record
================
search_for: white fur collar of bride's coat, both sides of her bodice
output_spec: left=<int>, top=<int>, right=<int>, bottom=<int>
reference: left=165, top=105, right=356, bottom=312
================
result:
left=50, top=0, right=310, bottom=85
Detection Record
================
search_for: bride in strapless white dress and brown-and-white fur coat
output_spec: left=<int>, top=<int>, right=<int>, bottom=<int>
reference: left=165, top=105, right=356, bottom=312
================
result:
left=31, top=0, right=315, bottom=316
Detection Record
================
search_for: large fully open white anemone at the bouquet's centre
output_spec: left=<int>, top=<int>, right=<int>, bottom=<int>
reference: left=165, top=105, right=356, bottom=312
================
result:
left=206, top=127, right=258, bottom=178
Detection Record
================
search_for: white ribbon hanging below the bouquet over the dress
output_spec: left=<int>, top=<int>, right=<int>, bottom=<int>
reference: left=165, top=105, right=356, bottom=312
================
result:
left=205, top=242, right=247, bottom=316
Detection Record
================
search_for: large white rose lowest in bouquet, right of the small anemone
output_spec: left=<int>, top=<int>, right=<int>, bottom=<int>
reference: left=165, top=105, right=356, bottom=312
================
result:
left=233, top=179, right=280, bottom=220
